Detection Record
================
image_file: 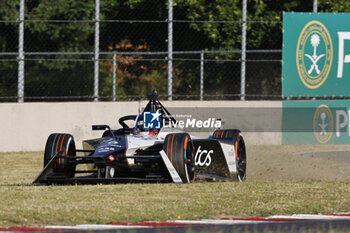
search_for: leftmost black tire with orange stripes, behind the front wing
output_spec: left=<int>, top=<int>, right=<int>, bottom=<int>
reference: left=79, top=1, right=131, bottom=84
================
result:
left=44, top=133, right=76, bottom=177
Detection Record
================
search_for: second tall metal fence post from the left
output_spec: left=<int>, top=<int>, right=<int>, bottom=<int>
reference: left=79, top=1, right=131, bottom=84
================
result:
left=94, top=0, right=100, bottom=101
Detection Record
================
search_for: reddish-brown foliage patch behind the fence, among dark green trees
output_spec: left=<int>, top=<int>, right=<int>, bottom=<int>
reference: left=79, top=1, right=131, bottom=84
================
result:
left=101, top=40, right=167, bottom=99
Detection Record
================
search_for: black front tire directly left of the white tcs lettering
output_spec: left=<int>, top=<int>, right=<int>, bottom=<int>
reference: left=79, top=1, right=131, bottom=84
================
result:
left=163, top=133, right=195, bottom=183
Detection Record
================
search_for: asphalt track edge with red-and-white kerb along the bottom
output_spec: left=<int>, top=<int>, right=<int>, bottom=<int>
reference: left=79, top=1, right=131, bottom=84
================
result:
left=0, top=213, right=350, bottom=233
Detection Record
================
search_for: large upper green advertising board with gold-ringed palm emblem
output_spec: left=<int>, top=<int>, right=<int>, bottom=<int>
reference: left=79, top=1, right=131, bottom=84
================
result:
left=282, top=12, right=350, bottom=97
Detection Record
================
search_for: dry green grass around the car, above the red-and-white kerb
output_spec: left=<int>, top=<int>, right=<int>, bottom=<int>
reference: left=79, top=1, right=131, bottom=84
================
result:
left=0, top=146, right=350, bottom=227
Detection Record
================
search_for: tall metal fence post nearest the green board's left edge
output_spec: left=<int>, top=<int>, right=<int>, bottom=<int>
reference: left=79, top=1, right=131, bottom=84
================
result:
left=241, top=0, right=247, bottom=100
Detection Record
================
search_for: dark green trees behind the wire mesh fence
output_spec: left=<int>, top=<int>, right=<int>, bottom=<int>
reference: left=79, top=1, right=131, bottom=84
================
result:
left=0, top=0, right=350, bottom=100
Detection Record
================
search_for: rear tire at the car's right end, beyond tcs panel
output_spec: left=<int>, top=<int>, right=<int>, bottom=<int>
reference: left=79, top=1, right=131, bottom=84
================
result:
left=233, top=130, right=247, bottom=182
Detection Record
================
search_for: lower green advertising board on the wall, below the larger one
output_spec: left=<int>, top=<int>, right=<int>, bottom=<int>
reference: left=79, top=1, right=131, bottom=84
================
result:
left=282, top=100, right=350, bottom=144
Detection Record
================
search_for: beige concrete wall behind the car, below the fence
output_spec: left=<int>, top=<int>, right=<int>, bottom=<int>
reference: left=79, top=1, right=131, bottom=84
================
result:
left=0, top=101, right=282, bottom=152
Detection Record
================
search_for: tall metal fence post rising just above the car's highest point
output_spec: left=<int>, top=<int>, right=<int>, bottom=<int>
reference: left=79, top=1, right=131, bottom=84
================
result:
left=168, top=0, right=173, bottom=100
